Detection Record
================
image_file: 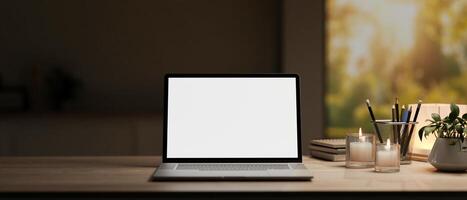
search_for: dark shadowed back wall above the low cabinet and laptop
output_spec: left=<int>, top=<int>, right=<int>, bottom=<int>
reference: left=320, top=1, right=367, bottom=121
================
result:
left=0, top=0, right=281, bottom=112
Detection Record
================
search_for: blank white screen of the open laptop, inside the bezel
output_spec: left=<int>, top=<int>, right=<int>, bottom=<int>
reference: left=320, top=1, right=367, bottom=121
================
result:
left=166, top=77, right=298, bottom=158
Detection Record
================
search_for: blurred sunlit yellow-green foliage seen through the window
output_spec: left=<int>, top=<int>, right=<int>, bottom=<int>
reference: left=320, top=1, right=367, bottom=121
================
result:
left=325, top=0, right=467, bottom=138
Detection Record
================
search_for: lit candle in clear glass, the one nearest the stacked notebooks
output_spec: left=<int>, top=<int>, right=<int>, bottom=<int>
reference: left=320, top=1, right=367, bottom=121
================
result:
left=345, top=133, right=375, bottom=168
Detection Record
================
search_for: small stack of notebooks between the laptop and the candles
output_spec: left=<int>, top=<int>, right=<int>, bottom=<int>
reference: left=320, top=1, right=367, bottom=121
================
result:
left=309, top=139, right=346, bottom=161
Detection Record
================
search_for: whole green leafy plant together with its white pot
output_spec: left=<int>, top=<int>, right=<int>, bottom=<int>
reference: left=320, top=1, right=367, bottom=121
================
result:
left=418, top=104, right=467, bottom=171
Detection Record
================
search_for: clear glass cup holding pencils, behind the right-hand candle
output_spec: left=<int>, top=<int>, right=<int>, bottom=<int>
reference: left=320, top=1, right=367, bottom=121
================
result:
left=372, top=120, right=417, bottom=165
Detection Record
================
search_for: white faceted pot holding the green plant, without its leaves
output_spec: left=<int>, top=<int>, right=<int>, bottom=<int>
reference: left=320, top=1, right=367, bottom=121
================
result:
left=428, top=138, right=467, bottom=171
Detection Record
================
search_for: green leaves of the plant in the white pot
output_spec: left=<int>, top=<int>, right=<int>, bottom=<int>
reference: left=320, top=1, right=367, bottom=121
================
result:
left=418, top=104, right=467, bottom=142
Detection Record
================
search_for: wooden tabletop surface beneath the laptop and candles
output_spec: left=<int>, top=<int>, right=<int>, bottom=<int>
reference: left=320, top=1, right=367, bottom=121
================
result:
left=0, top=156, right=467, bottom=193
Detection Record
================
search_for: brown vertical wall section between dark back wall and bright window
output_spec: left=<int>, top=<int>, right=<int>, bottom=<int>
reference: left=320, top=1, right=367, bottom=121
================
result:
left=282, top=0, right=325, bottom=154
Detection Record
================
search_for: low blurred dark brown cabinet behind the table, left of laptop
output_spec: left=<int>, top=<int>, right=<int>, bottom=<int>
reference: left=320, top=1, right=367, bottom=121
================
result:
left=0, top=113, right=163, bottom=156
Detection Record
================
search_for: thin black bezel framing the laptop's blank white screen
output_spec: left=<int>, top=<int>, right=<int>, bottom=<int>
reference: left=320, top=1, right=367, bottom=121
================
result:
left=162, top=74, right=302, bottom=163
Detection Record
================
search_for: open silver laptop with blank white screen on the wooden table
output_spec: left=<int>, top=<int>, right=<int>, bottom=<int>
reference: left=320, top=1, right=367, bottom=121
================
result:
left=152, top=74, right=312, bottom=181
